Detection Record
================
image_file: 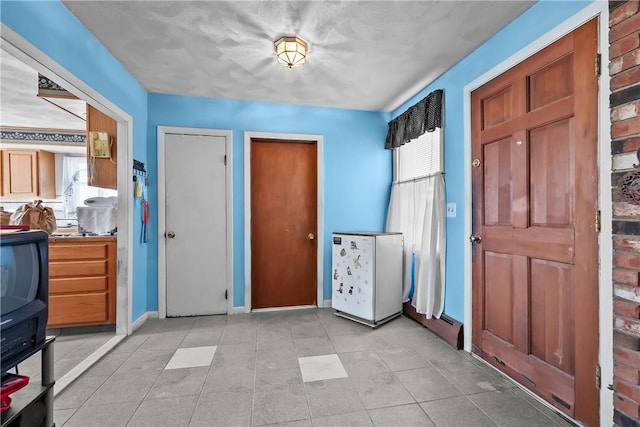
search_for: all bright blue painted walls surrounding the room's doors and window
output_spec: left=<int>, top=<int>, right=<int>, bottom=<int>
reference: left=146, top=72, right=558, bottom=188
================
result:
left=0, top=1, right=591, bottom=320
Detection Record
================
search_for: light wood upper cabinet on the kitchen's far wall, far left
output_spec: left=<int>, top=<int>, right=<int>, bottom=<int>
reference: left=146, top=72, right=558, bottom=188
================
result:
left=2, top=150, right=56, bottom=200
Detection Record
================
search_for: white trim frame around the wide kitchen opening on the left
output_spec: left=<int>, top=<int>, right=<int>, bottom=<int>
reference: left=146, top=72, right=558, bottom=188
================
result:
left=0, top=23, right=135, bottom=335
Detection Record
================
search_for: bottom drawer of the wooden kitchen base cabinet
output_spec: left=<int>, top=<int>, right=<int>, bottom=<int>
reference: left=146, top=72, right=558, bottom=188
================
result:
left=47, top=292, right=109, bottom=327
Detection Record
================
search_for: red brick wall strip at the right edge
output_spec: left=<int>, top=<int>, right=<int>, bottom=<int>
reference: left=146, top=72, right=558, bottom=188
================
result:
left=609, top=1, right=640, bottom=426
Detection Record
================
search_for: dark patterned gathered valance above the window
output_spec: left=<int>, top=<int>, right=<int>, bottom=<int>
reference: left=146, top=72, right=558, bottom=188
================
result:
left=384, top=89, right=444, bottom=150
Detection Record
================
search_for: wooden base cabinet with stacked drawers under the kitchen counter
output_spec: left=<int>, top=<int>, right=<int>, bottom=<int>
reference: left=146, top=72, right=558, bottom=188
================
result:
left=47, top=237, right=116, bottom=328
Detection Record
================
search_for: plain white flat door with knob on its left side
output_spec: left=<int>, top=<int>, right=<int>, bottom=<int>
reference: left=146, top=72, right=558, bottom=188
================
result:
left=164, top=134, right=227, bottom=317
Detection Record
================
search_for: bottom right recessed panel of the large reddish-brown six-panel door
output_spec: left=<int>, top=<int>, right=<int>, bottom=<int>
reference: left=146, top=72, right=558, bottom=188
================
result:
left=531, top=259, right=575, bottom=375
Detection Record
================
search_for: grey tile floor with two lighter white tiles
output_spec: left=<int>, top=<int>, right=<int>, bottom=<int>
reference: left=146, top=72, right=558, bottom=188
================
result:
left=54, top=309, right=571, bottom=427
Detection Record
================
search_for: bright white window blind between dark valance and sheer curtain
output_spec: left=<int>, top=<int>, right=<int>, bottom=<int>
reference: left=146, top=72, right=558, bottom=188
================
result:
left=393, top=128, right=444, bottom=182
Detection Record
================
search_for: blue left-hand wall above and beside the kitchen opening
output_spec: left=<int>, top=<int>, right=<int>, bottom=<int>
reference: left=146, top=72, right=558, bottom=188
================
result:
left=0, top=1, right=150, bottom=320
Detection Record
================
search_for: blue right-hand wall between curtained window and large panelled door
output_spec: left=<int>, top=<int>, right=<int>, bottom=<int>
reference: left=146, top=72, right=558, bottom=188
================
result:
left=391, top=1, right=592, bottom=321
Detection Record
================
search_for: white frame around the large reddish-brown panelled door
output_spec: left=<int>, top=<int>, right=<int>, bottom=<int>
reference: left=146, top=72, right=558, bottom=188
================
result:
left=463, top=1, right=613, bottom=425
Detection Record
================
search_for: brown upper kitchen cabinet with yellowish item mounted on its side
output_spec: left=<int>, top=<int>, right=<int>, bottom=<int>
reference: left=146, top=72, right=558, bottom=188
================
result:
left=87, top=104, right=118, bottom=190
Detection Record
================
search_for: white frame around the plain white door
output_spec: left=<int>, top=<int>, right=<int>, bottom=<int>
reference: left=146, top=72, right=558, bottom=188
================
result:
left=158, top=126, right=233, bottom=319
